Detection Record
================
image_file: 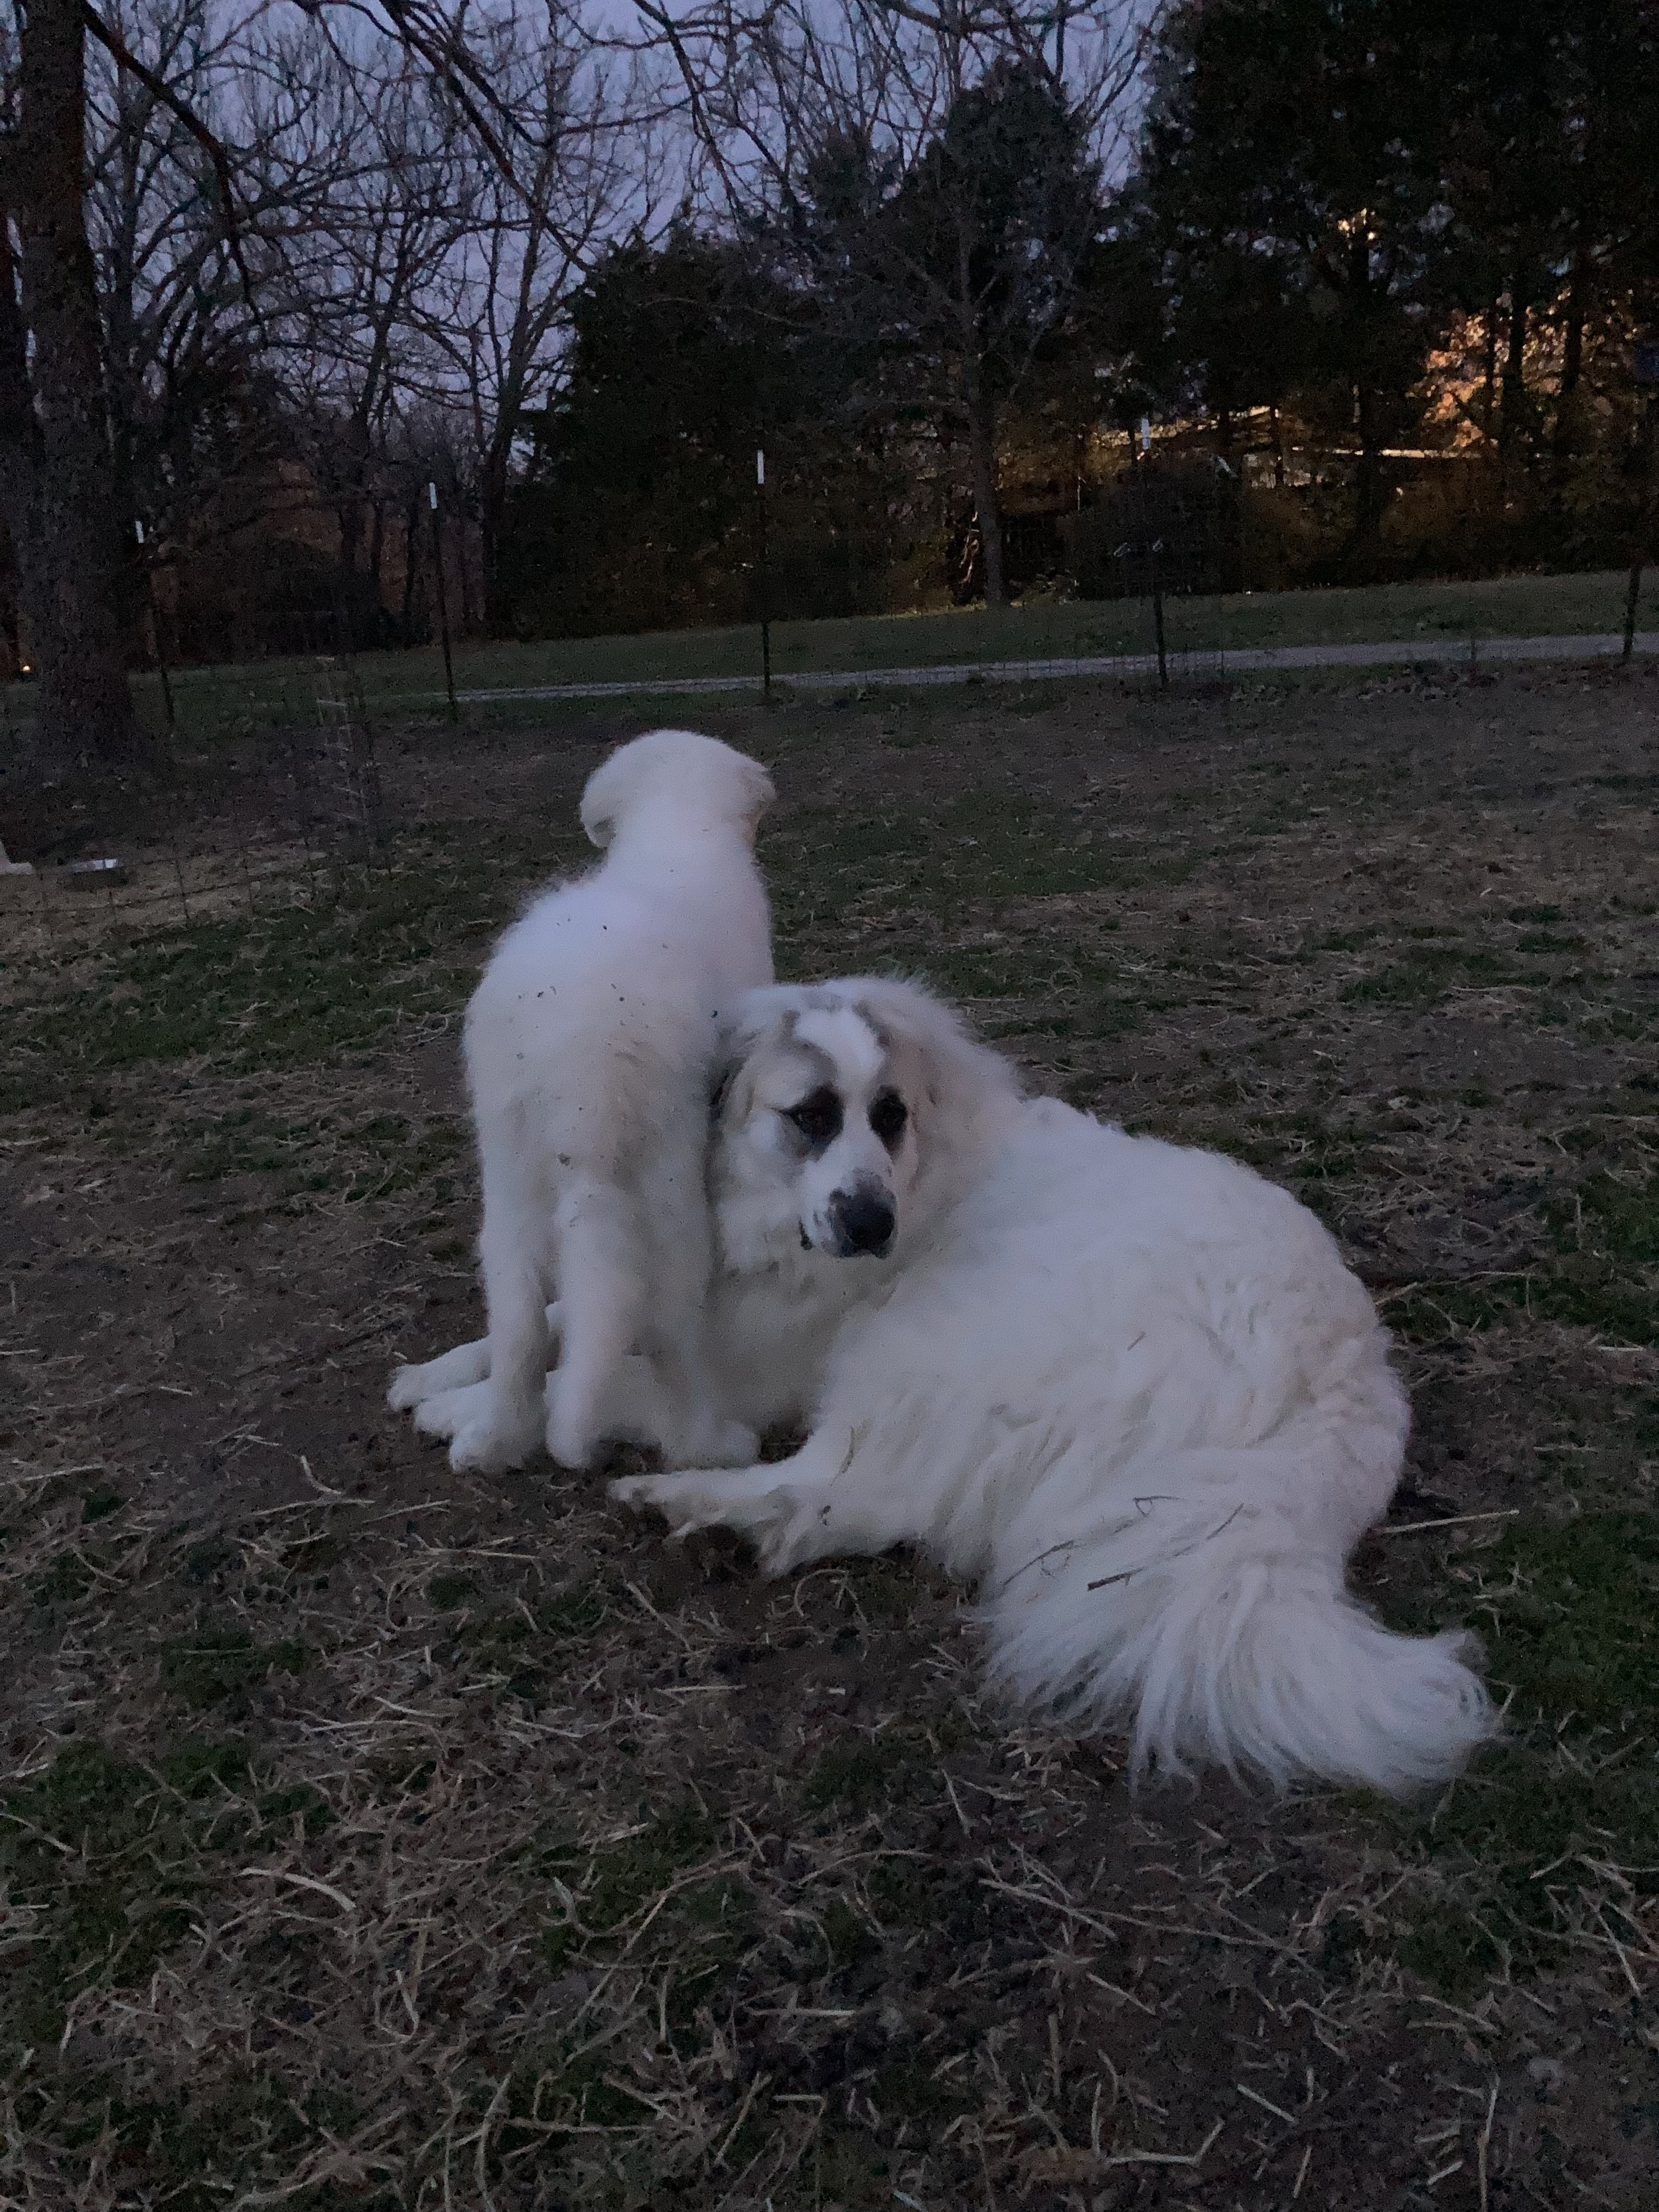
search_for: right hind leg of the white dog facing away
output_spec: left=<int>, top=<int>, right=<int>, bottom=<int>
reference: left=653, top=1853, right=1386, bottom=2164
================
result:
left=546, top=1177, right=648, bottom=1467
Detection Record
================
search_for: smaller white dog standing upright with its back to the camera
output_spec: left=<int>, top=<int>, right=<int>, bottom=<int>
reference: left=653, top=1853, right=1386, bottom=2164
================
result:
left=390, top=730, right=772, bottom=1471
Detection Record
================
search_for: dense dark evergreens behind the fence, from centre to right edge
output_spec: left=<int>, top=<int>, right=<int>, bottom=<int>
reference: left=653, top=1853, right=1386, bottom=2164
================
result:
left=498, top=0, right=1659, bottom=635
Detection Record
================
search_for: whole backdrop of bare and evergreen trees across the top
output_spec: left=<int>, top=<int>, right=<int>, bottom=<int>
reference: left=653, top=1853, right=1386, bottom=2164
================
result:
left=0, top=0, right=1659, bottom=761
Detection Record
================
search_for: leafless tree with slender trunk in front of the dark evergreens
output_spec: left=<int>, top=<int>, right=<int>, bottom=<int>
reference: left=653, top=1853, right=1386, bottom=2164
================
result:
left=619, top=0, right=1143, bottom=604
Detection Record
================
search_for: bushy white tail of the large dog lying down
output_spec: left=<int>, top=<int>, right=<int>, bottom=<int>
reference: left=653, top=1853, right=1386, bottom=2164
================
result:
left=989, top=1453, right=1498, bottom=1796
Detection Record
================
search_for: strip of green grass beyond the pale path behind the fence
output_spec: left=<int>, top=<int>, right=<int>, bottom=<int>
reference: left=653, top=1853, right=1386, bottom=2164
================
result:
left=0, top=573, right=1654, bottom=735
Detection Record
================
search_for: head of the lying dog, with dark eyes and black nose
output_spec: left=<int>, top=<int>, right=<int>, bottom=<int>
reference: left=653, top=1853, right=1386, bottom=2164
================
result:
left=715, top=978, right=1020, bottom=1265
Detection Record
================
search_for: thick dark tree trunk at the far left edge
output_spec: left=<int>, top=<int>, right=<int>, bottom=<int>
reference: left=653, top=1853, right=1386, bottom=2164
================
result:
left=9, top=0, right=153, bottom=774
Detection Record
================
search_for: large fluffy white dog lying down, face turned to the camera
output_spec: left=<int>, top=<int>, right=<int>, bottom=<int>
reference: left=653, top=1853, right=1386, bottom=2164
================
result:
left=615, top=982, right=1493, bottom=1792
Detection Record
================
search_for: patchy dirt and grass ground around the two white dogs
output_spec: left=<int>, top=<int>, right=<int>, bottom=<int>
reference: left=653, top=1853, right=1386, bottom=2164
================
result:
left=0, top=670, right=1659, bottom=2212
